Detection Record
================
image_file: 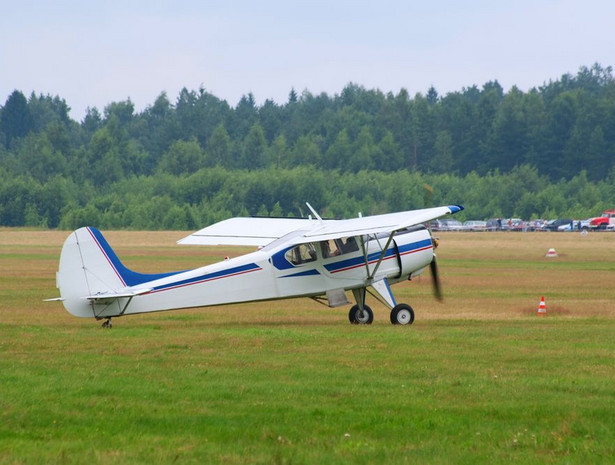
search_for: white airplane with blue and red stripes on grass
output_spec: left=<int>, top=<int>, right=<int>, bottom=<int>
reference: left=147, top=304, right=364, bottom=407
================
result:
left=49, top=204, right=463, bottom=327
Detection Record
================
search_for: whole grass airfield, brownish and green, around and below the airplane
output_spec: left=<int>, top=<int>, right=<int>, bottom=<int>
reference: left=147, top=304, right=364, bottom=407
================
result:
left=0, top=229, right=615, bottom=464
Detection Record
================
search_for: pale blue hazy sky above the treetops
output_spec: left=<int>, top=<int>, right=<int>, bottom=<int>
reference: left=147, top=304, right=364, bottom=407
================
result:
left=0, top=0, right=615, bottom=121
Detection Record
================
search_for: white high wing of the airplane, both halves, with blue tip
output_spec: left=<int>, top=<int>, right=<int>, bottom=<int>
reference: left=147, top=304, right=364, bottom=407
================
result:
left=178, top=205, right=463, bottom=246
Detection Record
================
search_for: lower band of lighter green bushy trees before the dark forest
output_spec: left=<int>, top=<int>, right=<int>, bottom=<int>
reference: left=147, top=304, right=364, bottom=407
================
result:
left=0, top=166, right=615, bottom=230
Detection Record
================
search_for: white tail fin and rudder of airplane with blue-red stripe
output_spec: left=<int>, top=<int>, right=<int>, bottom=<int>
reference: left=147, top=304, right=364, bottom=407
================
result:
left=56, top=227, right=173, bottom=318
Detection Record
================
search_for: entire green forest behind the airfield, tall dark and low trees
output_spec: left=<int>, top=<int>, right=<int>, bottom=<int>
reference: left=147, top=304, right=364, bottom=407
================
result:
left=0, top=64, right=615, bottom=229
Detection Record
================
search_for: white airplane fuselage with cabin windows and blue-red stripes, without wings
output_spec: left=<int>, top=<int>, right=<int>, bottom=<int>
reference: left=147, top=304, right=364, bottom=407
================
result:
left=79, top=227, right=434, bottom=318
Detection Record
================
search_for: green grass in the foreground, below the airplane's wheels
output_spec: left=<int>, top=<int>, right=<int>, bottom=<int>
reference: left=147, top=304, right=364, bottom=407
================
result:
left=0, top=314, right=615, bottom=463
